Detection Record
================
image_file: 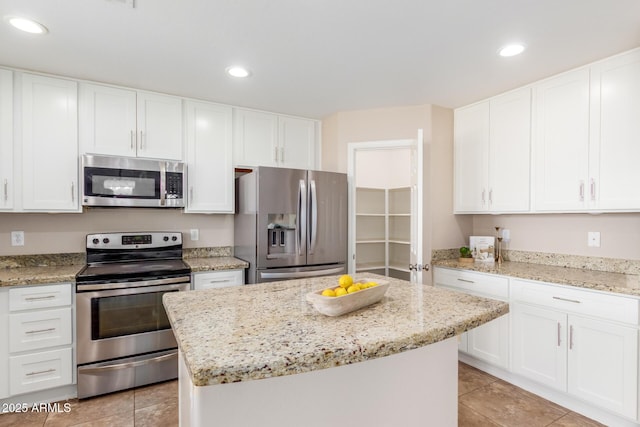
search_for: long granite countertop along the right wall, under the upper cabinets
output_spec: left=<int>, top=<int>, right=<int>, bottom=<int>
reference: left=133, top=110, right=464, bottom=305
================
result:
left=432, top=259, right=640, bottom=297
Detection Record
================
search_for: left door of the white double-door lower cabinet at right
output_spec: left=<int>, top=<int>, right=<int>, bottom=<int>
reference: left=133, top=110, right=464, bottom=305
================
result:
left=511, top=304, right=567, bottom=391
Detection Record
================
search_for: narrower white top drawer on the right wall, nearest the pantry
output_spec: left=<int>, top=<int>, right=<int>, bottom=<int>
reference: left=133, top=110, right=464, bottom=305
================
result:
left=433, top=267, right=509, bottom=300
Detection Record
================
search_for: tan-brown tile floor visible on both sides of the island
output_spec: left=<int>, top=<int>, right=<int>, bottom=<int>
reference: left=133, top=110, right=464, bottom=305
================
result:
left=0, top=363, right=602, bottom=427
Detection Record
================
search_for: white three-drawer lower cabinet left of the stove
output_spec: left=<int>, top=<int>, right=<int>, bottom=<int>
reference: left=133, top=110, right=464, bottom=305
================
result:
left=0, top=283, right=73, bottom=397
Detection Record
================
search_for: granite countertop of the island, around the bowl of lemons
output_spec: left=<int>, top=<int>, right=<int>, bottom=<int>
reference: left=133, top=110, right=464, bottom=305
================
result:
left=164, top=274, right=509, bottom=386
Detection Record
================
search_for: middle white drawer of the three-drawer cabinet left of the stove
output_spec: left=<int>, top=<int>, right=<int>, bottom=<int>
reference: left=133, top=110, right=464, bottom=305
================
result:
left=9, top=307, right=71, bottom=353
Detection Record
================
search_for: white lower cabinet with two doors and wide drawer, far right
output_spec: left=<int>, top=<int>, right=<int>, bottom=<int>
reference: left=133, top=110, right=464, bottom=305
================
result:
left=511, top=280, right=638, bottom=419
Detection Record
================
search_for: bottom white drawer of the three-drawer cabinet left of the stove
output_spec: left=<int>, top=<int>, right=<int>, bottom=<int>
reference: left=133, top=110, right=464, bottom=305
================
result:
left=9, top=348, right=72, bottom=395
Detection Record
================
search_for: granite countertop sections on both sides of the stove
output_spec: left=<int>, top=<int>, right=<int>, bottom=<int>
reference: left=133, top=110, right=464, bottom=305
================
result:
left=0, top=256, right=248, bottom=288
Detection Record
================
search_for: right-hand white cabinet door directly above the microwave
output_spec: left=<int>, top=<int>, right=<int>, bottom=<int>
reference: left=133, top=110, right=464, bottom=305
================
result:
left=137, top=92, right=182, bottom=160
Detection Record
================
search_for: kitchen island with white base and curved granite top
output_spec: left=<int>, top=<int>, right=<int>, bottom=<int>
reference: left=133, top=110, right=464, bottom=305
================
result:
left=164, top=274, right=509, bottom=426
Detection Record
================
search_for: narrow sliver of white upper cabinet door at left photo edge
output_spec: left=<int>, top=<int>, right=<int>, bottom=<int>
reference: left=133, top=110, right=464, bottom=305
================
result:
left=0, top=70, right=13, bottom=210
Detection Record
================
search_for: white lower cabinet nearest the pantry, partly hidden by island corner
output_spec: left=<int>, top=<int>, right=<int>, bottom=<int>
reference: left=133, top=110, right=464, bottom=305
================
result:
left=433, top=267, right=509, bottom=369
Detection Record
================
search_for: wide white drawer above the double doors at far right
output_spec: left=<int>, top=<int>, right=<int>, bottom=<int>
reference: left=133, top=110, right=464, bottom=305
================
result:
left=511, top=279, right=638, bottom=325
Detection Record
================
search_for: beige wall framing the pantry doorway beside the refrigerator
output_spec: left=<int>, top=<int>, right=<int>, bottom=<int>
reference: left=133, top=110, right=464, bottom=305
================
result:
left=322, top=105, right=473, bottom=270
